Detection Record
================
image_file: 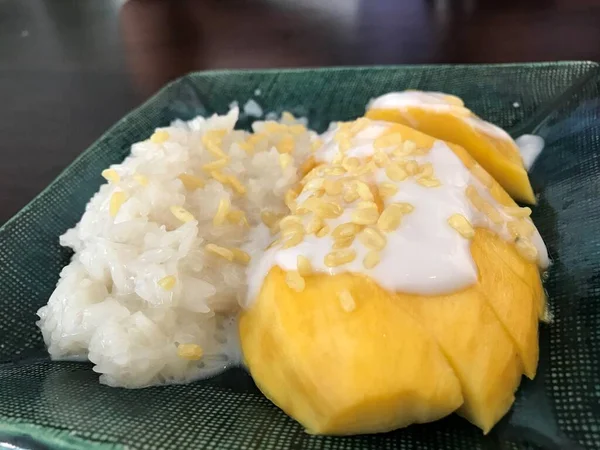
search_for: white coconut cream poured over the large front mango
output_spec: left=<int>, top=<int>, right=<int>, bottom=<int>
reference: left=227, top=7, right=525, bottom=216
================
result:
left=248, top=121, right=549, bottom=299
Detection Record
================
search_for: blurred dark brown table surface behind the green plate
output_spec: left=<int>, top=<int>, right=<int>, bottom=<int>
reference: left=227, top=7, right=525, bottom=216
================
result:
left=0, top=0, right=600, bottom=224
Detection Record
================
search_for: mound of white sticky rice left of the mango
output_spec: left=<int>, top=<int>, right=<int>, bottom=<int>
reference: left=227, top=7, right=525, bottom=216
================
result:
left=38, top=108, right=318, bottom=388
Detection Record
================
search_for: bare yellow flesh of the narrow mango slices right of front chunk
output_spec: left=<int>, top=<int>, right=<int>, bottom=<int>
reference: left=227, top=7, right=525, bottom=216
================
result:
left=397, top=229, right=528, bottom=433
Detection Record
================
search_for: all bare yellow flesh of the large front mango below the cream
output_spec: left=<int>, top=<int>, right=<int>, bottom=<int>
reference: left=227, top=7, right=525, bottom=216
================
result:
left=240, top=229, right=539, bottom=435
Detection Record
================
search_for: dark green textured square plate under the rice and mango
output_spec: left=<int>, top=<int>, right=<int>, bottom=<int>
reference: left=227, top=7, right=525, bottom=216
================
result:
left=0, top=62, right=600, bottom=450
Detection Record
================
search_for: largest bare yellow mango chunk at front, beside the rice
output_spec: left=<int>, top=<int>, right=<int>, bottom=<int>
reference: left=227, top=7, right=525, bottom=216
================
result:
left=240, top=267, right=464, bottom=435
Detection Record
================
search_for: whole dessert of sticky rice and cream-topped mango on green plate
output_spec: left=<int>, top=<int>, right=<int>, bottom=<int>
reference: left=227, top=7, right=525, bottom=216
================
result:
left=38, top=92, right=549, bottom=435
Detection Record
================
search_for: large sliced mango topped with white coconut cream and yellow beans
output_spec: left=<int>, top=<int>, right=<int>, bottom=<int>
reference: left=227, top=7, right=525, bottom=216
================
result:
left=240, top=118, right=548, bottom=434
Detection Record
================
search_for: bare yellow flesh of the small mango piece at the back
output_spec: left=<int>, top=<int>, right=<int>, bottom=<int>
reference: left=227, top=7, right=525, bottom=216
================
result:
left=366, top=106, right=535, bottom=204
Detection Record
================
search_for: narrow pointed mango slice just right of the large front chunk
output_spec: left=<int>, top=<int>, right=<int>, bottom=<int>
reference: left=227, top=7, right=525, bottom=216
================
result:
left=396, top=276, right=520, bottom=433
